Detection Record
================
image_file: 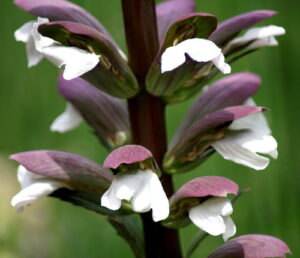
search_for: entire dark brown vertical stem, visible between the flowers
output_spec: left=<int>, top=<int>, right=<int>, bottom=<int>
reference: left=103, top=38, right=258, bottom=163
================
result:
left=122, top=0, right=182, bottom=258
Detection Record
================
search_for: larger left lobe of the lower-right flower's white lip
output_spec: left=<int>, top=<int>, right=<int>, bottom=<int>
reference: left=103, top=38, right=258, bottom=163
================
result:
left=189, top=197, right=228, bottom=236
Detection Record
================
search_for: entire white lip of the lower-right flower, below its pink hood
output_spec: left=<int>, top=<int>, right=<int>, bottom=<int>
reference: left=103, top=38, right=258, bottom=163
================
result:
left=189, top=197, right=236, bottom=241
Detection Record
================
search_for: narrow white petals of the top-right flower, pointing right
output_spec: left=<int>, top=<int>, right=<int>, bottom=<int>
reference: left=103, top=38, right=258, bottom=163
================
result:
left=228, top=25, right=285, bottom=49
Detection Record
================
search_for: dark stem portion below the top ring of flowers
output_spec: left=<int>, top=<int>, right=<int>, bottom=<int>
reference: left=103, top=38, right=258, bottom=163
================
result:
left=128, top=93, right=182, bottom=258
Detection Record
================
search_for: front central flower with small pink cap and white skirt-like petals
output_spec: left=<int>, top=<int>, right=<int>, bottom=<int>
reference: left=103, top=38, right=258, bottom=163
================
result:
left=101, top=145, right=169, bottom=222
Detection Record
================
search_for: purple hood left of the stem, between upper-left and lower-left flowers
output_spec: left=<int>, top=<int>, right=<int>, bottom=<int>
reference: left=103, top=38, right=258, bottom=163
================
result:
left=58, top=76, right=130, bottom=149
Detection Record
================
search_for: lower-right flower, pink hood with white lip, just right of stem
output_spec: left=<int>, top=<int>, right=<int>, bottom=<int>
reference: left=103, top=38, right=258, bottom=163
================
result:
left=165, top=176, right=238, bottom=241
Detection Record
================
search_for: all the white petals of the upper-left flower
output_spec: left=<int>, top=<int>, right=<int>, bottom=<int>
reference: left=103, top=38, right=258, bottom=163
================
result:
left=15, top=17, right=100, bottom=80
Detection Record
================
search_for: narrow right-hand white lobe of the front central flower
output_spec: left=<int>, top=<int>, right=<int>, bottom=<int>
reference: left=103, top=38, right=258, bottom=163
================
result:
left=150, top=173, right=170, bottom=222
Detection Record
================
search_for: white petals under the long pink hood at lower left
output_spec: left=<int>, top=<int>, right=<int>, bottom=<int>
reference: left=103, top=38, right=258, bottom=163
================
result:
left=11, top=165, right=70, bottom=212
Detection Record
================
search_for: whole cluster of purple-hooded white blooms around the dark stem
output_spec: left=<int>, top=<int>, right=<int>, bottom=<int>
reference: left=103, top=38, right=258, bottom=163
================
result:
left=11, top=0, right=290, bottom=257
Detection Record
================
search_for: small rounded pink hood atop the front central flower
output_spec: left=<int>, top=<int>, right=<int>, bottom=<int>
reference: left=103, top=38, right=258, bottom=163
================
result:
left=103, top=144, right=153, bottom=169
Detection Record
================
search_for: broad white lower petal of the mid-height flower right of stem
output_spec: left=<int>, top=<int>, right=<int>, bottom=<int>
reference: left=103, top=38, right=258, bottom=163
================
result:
left=212, top=130, right=276, bottom=170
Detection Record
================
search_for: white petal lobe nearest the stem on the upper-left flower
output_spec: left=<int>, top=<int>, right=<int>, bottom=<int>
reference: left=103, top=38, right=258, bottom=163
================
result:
left=40, top=45, right=100, bottom=80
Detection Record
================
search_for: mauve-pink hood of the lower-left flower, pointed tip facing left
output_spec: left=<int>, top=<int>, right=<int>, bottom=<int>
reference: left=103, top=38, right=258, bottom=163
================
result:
left=10, top=150, right=112, bottom=193
